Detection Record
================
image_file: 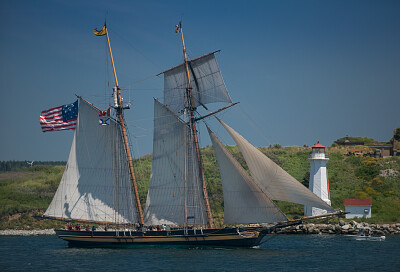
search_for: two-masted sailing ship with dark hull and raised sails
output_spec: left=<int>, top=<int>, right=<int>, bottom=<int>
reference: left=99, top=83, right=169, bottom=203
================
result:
left=44, top=24, right=335, bottom=247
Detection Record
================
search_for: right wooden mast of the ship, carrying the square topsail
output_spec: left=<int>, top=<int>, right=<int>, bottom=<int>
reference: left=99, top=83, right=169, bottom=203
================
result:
left=179, top=23, right=214, bottom=228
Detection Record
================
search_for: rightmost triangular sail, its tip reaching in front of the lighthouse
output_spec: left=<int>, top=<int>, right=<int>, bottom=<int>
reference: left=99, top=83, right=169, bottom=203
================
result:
left=217, top=118, right=334, bottom=212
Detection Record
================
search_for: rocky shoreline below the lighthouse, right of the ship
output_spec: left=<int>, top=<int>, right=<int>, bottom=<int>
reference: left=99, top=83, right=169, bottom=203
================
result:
left=272, top=220, right=400, bottom=235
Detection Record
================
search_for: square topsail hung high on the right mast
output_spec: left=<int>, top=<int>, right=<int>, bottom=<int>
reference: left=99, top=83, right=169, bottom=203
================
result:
left=164, top=53, right=232, bottom=115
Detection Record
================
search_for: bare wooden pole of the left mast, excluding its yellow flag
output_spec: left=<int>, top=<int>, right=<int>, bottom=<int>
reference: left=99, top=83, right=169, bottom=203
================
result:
left=106, top=27, right=144, bottom=226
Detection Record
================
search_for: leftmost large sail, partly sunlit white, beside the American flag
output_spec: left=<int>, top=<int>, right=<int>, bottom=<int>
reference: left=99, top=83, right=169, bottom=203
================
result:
left=45, top=99, right=138, bottom=223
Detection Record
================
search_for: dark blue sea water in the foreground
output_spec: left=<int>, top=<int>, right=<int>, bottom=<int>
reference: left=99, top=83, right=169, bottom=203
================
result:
left=0, top=235, right=400, bottom=271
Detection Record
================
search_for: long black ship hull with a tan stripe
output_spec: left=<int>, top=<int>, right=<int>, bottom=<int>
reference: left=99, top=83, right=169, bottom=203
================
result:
left=55, top=228, right=266, bottom=247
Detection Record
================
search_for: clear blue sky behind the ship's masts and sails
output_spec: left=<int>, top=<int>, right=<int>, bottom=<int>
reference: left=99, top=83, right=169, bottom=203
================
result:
left=0, top=0, right=400, bottom=160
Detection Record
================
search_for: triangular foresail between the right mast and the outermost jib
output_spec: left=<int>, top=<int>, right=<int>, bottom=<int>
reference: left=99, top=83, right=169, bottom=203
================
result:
left=208, top=129, right=287, bottom=224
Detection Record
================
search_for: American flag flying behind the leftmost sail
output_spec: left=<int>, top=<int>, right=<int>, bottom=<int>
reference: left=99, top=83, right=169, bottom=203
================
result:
left=40, top=100, right=78, bottom=132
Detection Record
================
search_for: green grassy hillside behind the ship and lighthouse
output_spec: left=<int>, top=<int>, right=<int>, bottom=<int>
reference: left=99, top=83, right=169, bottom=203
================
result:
left=0, top=149, right=400, bottom=229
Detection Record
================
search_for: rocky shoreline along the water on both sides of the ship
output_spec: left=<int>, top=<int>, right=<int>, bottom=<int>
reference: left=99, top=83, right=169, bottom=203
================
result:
left=0, top=220, right=400, bottom=236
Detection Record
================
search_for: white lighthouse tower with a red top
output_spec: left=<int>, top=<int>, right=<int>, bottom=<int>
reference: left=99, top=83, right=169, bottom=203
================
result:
left=304, top=141, right=331, bottom=216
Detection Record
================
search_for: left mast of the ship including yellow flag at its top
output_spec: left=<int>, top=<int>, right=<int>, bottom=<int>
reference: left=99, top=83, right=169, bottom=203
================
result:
left=94, top=24, right=144, bottom=226
